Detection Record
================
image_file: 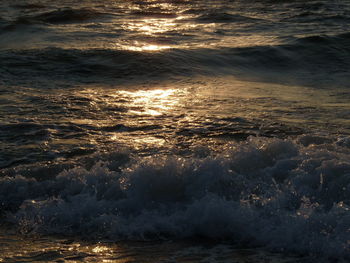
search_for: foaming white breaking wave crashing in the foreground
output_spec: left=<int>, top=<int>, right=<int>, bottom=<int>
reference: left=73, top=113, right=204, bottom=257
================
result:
left=0, top=137, right=350, bottom=259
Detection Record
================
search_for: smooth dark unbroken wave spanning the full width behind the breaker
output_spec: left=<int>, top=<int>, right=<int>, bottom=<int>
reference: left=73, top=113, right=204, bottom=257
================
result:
left=0, top=33, right=350, bottom=85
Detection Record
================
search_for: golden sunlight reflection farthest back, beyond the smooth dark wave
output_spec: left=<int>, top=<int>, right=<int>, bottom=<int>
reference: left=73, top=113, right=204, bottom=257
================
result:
left=114, top=3, right=280, bottom=52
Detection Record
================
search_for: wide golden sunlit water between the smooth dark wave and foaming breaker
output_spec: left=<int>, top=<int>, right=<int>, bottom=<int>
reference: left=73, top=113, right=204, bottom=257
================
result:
left=39, top=77, right=348, bottom=159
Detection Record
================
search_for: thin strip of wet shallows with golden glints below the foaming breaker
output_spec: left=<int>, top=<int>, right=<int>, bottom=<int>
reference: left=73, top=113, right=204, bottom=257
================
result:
left=0, top=231, right=304, bottom=263
